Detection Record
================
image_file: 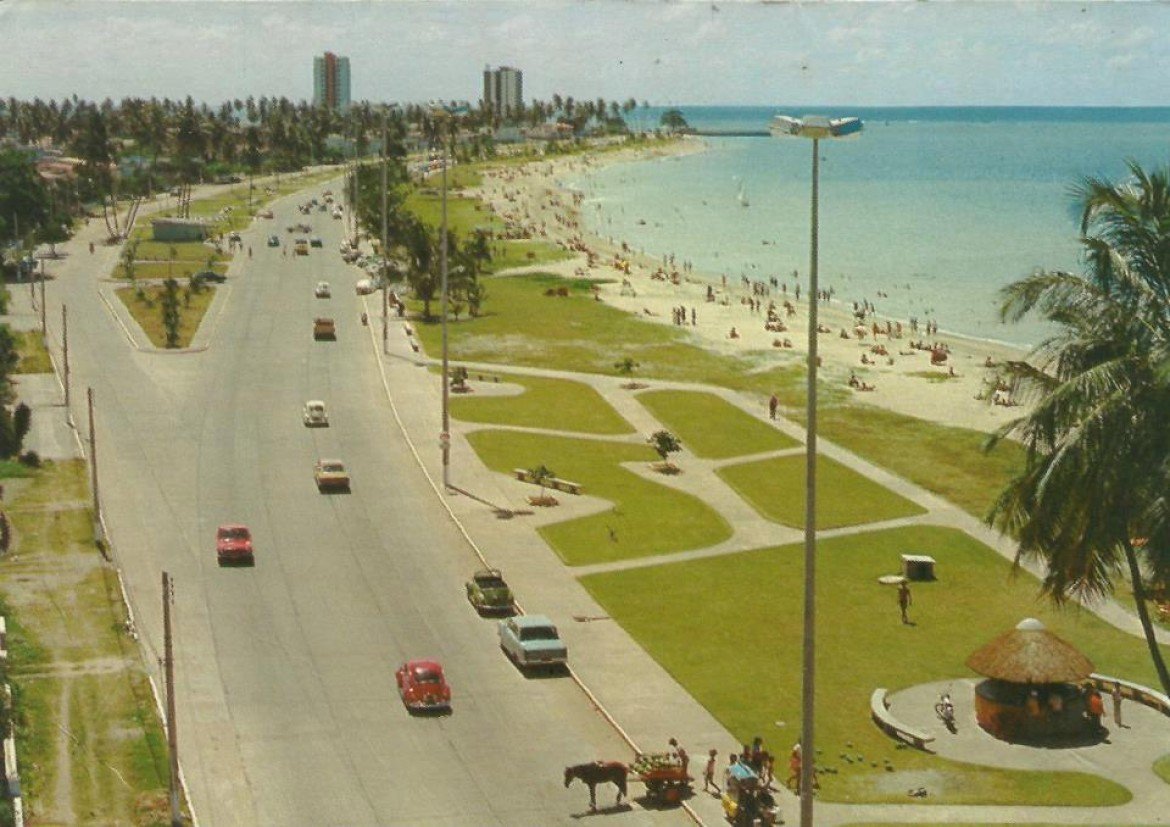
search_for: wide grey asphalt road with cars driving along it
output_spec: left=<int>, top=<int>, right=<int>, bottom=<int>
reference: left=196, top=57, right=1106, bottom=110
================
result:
left=49, top=187, right=686, bottom=827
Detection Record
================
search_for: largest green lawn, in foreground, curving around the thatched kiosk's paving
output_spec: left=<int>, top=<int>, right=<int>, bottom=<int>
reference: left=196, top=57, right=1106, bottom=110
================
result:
left=581, top=526, right=1156, bottom=806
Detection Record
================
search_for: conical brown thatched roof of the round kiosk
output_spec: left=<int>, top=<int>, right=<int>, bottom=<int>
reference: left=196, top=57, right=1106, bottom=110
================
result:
left=966, top=618, right=1094, bottom=683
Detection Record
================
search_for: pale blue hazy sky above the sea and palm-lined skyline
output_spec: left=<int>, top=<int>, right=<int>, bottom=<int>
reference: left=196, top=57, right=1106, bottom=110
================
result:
left=0, top=0, right=1170, bottom=106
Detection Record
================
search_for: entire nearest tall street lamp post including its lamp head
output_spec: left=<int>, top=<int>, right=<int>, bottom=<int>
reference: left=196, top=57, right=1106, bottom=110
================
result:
left=771, top=116, right=861, bottom=827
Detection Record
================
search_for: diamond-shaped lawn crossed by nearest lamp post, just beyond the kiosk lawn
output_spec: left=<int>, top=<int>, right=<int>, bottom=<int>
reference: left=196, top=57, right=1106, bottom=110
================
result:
left=716, top=454, right=924, bottom=529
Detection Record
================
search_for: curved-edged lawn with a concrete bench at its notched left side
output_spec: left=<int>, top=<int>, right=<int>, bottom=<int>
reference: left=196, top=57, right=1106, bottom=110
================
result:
left=468, top=430, right=731, bottom=566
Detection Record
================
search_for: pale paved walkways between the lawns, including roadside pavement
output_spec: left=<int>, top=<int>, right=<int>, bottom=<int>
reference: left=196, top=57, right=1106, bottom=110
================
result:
left=371, top=313, right=1170, bottom=825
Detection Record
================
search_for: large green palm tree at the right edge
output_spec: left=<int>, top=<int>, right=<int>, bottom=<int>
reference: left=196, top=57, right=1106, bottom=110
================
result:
left=987, top=161, right=1170, bottom=692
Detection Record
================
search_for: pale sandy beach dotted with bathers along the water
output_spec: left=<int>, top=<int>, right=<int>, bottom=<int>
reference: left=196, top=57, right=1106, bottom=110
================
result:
left=468, top=139, right=1025, bottom=432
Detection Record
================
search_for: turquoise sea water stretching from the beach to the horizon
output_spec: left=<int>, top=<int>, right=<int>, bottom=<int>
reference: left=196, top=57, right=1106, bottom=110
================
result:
left=569, top=106, right=1170, bottom=345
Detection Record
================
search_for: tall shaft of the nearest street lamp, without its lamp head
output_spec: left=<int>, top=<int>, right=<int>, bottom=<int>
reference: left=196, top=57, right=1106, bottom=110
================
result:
left=800, top=138, right=820, bottom=827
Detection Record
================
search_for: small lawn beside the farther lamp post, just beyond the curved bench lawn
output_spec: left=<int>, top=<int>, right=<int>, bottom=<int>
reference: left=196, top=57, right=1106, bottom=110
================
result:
left=450, top=374, right=634, bottom=434
